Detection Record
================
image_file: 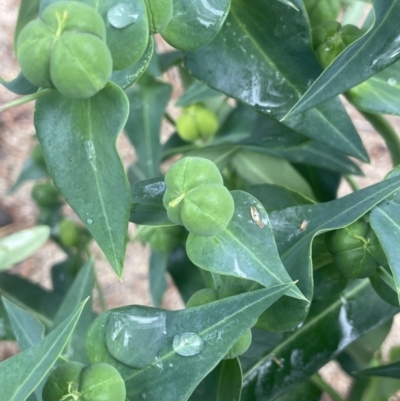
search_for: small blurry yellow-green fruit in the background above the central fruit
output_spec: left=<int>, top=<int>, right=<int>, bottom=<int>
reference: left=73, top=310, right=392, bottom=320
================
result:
left=176, top=104, right=218, bottom=142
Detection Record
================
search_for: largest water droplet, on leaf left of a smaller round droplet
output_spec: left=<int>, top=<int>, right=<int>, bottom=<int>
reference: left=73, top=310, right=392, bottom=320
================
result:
left=106, top=306, right=167, bottom=369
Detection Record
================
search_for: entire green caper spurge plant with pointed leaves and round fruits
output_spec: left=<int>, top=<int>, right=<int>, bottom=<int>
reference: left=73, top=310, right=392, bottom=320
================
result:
left=0, top=0, right=400, bottom=401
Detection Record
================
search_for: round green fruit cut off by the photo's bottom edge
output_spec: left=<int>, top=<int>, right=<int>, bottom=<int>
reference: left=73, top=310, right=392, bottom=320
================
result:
left=42, top=362, right=126, bottom=401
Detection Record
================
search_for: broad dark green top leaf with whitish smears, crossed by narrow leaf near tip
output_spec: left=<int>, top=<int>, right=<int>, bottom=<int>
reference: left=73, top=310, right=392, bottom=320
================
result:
left=185, top=0, right=368, bottom=161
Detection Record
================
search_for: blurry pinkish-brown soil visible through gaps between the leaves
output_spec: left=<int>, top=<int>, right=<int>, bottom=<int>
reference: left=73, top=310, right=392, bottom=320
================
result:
left=0, top=0, right=400, bottom=401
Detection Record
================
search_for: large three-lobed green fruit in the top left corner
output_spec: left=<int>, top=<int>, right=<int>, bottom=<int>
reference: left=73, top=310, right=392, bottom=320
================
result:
left=17, top=1, right=112, bottom=98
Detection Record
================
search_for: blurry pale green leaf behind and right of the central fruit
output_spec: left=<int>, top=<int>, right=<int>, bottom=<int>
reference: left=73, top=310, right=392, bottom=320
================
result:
left=233, top=150, right=314, bottom=198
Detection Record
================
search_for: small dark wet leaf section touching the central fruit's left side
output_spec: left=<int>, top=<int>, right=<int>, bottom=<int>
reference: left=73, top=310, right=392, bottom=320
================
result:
left=129, top=178, right=174, bottom=226
